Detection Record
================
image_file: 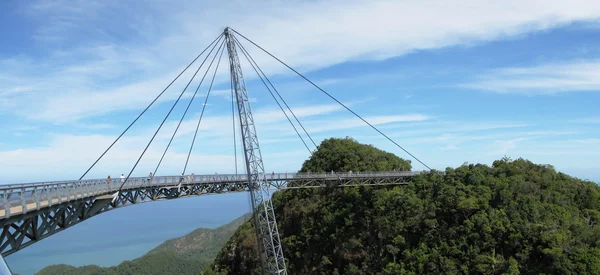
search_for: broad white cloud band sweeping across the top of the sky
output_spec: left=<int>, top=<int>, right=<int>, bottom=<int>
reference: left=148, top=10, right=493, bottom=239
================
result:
left=0, top=0, right=600, bottom=122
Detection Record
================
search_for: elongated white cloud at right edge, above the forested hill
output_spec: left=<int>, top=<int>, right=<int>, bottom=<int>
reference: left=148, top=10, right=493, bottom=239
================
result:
left=462, top=61, right=600, bottom=95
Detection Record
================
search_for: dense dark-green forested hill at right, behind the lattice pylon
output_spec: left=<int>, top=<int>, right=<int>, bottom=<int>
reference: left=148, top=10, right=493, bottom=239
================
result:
left=205, top=139, right=600, bottom=274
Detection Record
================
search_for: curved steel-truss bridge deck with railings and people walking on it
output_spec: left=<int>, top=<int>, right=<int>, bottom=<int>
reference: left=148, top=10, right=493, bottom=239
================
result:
left=0, top=171, right=422, bottom=256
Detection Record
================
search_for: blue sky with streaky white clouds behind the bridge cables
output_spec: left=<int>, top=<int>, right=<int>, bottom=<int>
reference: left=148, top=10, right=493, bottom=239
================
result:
left=0, top=0, right=600, bottom=183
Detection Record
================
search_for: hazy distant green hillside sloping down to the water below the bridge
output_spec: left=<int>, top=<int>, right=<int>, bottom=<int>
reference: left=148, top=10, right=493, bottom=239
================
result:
left=36, top=214, right=251, bottom=275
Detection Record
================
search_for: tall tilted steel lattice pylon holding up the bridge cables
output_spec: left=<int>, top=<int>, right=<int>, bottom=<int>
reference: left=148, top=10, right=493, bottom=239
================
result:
left=224, top=28, right=287, bottom=274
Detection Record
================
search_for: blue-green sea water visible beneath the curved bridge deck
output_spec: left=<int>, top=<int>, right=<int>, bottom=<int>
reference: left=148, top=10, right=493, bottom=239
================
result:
left=5, top=192, right=250, bottom=275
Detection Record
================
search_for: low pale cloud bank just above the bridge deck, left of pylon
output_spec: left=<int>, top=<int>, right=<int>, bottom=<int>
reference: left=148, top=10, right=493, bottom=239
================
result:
left=0, top=135, right=233, bottom=185
